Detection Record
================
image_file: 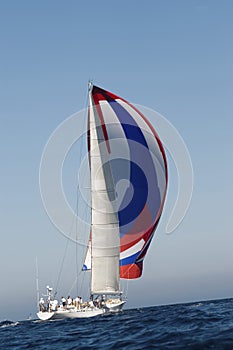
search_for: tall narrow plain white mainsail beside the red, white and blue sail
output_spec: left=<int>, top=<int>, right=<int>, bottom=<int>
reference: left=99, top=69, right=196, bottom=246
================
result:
left=88, top=82, right=120, bottom=295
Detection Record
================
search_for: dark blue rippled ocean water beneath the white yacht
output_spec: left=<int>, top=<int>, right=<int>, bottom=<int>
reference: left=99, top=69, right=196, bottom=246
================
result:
left=0, top=299, right=233, bottom=350
